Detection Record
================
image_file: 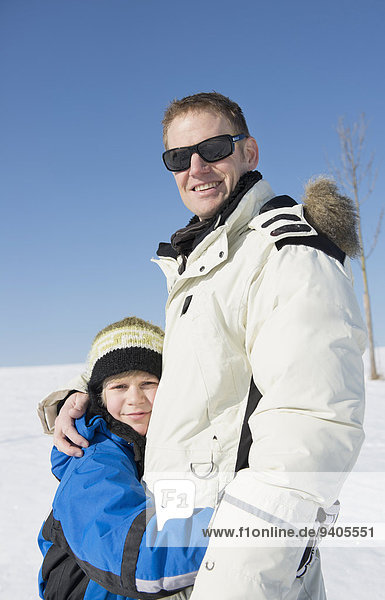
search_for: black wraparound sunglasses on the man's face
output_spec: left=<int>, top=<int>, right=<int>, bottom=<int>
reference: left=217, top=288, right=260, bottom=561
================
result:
left=162, top=133, right=246, bottom=172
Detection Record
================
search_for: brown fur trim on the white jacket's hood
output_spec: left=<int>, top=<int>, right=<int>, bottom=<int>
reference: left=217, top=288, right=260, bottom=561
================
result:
left=302, top=176, right=360, bottom=258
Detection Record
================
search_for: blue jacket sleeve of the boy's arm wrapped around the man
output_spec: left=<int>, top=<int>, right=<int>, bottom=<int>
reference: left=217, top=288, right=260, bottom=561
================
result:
left=50, top=440, right=212, bottom=599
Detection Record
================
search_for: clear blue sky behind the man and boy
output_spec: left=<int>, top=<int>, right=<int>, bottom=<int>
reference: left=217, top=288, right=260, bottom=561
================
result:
left=0, top=0, right=385, bottom=366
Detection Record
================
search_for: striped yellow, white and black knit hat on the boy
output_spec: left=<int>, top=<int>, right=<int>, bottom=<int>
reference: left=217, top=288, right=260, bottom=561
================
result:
left=87, top=317, right=164, bottom=391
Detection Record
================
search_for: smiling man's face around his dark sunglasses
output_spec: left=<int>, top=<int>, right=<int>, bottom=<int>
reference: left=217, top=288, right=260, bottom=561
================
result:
left=167, top=110, right=258, bottom=220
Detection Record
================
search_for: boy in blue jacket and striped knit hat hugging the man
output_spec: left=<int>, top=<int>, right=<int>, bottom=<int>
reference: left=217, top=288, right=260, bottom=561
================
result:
left=39, top=317, right=212, bottom=600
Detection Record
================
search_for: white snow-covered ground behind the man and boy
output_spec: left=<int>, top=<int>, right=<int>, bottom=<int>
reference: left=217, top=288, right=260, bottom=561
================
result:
left=0, top=348, right=385, bottom=600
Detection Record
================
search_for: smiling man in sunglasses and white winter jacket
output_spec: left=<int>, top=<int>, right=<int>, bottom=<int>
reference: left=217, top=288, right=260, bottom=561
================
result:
left=39, top=93, right=365, bottom=600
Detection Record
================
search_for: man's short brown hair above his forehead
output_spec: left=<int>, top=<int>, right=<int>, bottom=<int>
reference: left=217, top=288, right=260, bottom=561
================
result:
left=162, top=92, right=250, bottom=148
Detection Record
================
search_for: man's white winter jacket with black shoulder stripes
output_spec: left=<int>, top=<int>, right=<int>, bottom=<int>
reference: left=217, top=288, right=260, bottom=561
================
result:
left=145, top=181, right=365, bottom=600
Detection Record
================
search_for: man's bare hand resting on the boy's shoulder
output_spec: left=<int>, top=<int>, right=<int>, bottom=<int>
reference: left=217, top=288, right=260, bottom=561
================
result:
left=53, top=392, right=89, bottom=456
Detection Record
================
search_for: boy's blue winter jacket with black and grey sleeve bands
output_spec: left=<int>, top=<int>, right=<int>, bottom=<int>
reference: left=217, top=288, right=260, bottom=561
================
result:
left=39, top=416, right=212, bottom=600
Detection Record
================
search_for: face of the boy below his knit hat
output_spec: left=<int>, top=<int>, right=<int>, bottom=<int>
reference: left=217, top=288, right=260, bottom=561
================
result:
left=103, top=371, right=159, bottom=435
